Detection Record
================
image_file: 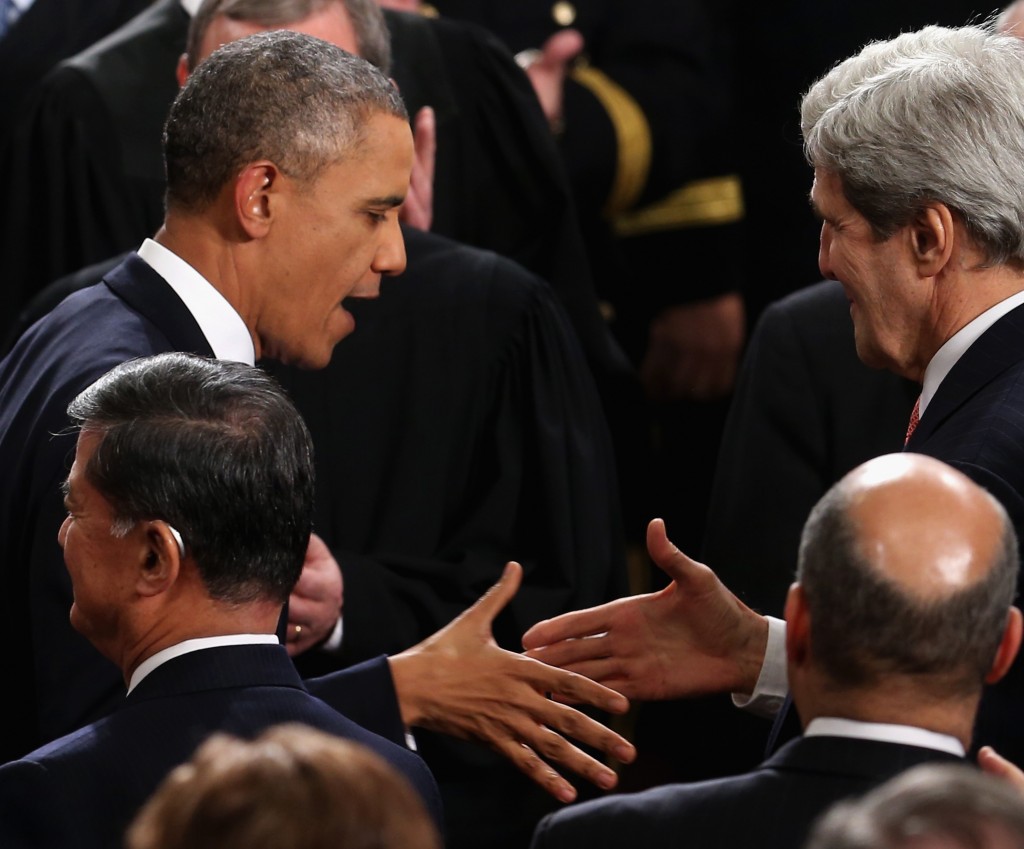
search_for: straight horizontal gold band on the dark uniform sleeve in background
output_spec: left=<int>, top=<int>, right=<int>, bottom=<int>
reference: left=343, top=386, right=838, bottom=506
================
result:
left=613, top=174, right=743, bottom=236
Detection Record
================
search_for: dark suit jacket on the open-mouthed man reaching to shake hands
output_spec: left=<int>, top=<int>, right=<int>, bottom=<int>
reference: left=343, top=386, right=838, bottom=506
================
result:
left=0, top=255, right=401, bottom=762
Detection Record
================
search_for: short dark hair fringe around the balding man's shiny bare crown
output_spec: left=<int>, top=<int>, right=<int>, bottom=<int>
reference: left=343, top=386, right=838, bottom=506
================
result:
left=797, top=473, right=1019, bottom=695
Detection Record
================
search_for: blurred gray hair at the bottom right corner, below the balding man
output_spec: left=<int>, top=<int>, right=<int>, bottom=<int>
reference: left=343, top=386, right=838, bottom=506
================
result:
left=805, top=764, right=1024, bottom=849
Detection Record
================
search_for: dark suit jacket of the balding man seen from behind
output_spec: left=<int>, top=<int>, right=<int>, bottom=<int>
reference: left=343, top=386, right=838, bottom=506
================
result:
left=534, top=736, right=959, bottom=849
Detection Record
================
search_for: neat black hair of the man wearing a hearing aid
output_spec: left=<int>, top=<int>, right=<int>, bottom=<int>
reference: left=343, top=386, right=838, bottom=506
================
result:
left=68, top=353, right=313, bottom=602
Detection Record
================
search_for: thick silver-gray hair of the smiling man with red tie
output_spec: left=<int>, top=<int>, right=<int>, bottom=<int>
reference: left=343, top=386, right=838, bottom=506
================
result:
left=801, top=27, right=1024, bottom=264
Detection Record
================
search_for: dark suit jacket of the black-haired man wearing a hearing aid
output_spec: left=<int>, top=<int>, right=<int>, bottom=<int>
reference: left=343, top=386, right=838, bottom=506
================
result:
left=0, top=645, right=441, bottom=849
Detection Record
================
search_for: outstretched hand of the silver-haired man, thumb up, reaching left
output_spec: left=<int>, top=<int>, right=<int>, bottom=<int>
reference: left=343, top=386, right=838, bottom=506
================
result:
left=523, top=519, right=768, bottom=701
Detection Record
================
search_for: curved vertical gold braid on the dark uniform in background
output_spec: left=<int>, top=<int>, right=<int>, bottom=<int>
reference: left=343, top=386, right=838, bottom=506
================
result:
left=572, top=66, right=651, bottom=218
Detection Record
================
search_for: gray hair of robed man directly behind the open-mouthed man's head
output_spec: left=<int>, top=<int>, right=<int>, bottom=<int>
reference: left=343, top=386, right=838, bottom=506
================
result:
left=185, top=0, right=391, bottom=74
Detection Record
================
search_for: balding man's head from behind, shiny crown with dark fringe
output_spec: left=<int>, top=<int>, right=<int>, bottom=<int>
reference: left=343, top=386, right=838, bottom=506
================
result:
left=797, top=454, right=1018, bottom=695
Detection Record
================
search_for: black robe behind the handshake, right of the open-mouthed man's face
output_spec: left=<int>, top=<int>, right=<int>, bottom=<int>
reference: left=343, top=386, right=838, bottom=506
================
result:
left=271, top=229, right=628, bottom=849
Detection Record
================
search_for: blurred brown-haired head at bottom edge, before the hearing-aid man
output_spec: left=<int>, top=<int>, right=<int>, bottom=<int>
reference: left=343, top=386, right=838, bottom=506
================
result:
left=127, top=724, right=441, bottom=849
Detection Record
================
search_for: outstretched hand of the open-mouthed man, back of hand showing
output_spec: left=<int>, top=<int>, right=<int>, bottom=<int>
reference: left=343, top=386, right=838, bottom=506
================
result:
left=389, top=562, right=636, bottom=802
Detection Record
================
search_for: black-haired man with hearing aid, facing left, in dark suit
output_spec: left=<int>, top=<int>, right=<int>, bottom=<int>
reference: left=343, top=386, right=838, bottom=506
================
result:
left=0, top=353, right=441, bottom=849
